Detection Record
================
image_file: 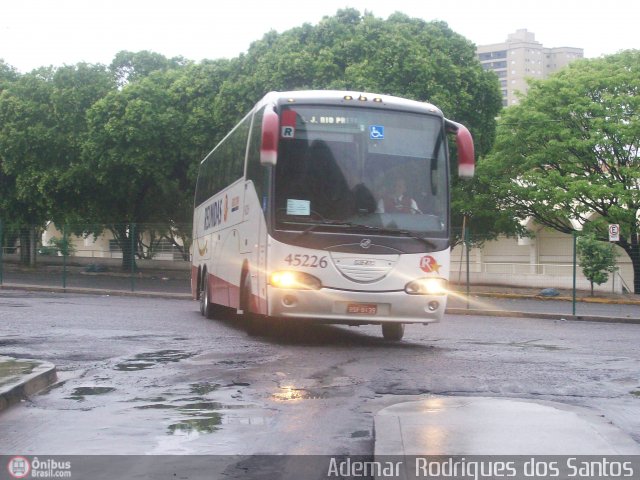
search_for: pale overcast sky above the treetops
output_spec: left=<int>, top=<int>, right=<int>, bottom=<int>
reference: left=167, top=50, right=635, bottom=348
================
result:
left=0, top=0, right=640, bottom=73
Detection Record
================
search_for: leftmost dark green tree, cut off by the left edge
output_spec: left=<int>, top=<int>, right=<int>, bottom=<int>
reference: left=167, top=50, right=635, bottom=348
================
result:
left=0, top=64, right=115, bottom=263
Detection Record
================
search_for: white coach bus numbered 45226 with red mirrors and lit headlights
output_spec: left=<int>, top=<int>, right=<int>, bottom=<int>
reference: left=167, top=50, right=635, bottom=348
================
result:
left=191, top=91, right=474, bottom=340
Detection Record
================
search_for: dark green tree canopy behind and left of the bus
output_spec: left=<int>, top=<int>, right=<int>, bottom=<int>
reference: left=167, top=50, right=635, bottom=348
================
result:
left=0, top=9, right=501, bottom=266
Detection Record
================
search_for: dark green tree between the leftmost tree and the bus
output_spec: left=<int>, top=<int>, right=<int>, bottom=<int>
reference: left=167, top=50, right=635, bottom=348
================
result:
left=75, top=70, right=194, bottom=269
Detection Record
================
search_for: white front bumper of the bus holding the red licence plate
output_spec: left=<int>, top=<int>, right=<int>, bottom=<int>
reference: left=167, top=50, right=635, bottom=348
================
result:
left=268, top=287, right=447, bottom=324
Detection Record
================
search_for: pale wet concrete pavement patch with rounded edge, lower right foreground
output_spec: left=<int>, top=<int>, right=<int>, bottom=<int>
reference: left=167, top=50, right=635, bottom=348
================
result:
left=374, top=396, right=640, bottom=479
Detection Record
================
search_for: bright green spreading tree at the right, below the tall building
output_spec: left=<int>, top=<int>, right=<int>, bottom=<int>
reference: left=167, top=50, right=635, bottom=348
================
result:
left=478, top=50, right=640, bottom=293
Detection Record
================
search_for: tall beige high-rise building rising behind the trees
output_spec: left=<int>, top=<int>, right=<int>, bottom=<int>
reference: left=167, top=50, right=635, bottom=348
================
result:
left=476, top=29, right=584, bottom=106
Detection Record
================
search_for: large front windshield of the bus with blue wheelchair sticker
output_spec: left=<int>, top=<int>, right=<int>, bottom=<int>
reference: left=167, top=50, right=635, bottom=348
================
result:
left=275, top=105, right=448, bottom=238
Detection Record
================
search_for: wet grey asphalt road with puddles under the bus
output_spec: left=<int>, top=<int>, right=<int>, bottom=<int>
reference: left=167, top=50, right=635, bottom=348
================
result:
left=0, top=290, right=640, bottom=455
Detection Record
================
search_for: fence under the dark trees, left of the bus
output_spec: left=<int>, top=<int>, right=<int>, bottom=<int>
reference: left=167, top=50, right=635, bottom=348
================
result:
left=0, top=223, right=191, bottom=294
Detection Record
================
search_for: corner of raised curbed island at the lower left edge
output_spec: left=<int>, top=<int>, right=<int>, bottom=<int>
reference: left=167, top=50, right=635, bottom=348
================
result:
left=0, top=356, right=58, bottom=411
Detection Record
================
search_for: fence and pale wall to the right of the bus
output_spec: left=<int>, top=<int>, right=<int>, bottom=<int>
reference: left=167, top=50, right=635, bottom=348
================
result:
left=449, top=230, right=640, bottom=319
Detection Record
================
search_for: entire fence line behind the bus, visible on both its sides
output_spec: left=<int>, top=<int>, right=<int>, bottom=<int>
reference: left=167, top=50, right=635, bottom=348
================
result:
left=0, top=222, right=640, bottom=318
